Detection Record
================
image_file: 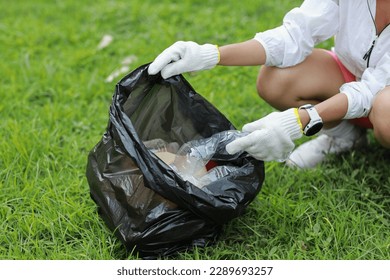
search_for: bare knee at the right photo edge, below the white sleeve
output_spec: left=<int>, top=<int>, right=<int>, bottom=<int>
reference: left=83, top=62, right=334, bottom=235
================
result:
left=369, top=87, right=390, bottom=148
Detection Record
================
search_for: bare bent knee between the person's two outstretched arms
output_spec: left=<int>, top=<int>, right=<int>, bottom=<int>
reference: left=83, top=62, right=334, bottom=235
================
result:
left=257, top=49, right=344, bottom=110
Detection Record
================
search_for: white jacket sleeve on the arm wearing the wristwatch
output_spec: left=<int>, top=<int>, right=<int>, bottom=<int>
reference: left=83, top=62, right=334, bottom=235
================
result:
left=340, top=52, right=390, bottom=119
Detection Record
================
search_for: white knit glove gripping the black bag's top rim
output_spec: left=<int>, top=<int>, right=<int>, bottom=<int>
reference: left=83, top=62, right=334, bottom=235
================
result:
left=148, top=41, right=220, bottom=79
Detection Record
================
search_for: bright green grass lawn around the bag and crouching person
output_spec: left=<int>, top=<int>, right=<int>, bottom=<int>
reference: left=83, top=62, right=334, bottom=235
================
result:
left=0, top=0, right=390, bottom=260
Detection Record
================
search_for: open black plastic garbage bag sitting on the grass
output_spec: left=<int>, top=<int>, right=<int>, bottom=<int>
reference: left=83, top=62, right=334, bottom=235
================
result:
left=86, top=64, right=264, bottom=258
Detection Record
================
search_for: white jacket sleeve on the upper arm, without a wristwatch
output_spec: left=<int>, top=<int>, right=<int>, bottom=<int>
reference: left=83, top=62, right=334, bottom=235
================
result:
left=254, top=0, right=339, bottom=67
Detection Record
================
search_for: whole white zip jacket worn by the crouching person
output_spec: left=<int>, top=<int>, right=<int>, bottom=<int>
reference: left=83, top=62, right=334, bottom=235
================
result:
left=255, top=0, right=390, bottom=119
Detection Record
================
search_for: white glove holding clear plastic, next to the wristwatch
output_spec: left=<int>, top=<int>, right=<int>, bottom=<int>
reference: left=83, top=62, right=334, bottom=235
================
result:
left=226, top=108, right=303, bottom=161
